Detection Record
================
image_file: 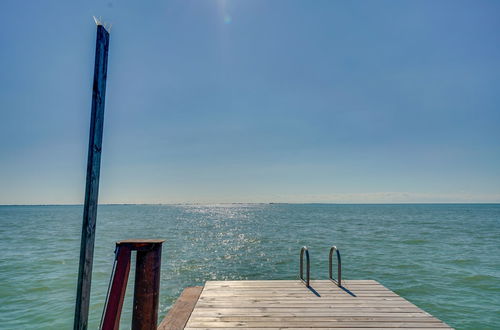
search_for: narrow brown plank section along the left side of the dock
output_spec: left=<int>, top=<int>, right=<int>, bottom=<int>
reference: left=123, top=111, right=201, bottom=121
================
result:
left=158, top=286, right=203, bottom=330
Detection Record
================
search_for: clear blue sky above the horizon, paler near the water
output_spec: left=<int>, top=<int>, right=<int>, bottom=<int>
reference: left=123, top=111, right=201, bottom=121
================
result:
left=0, top=0, right=500, bottom=204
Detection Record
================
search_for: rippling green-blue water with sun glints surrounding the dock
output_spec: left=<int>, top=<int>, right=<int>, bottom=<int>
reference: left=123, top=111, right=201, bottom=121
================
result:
left=0, top=204, right=500, bottom=329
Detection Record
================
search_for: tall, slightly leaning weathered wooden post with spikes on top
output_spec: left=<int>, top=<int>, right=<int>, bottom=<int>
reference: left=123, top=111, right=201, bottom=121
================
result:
left=73, top=19, right=109, bottom=330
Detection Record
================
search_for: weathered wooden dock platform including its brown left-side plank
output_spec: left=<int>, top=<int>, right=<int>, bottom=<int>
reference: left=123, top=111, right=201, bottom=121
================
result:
left=158, top=280, right=451, bottom=330
